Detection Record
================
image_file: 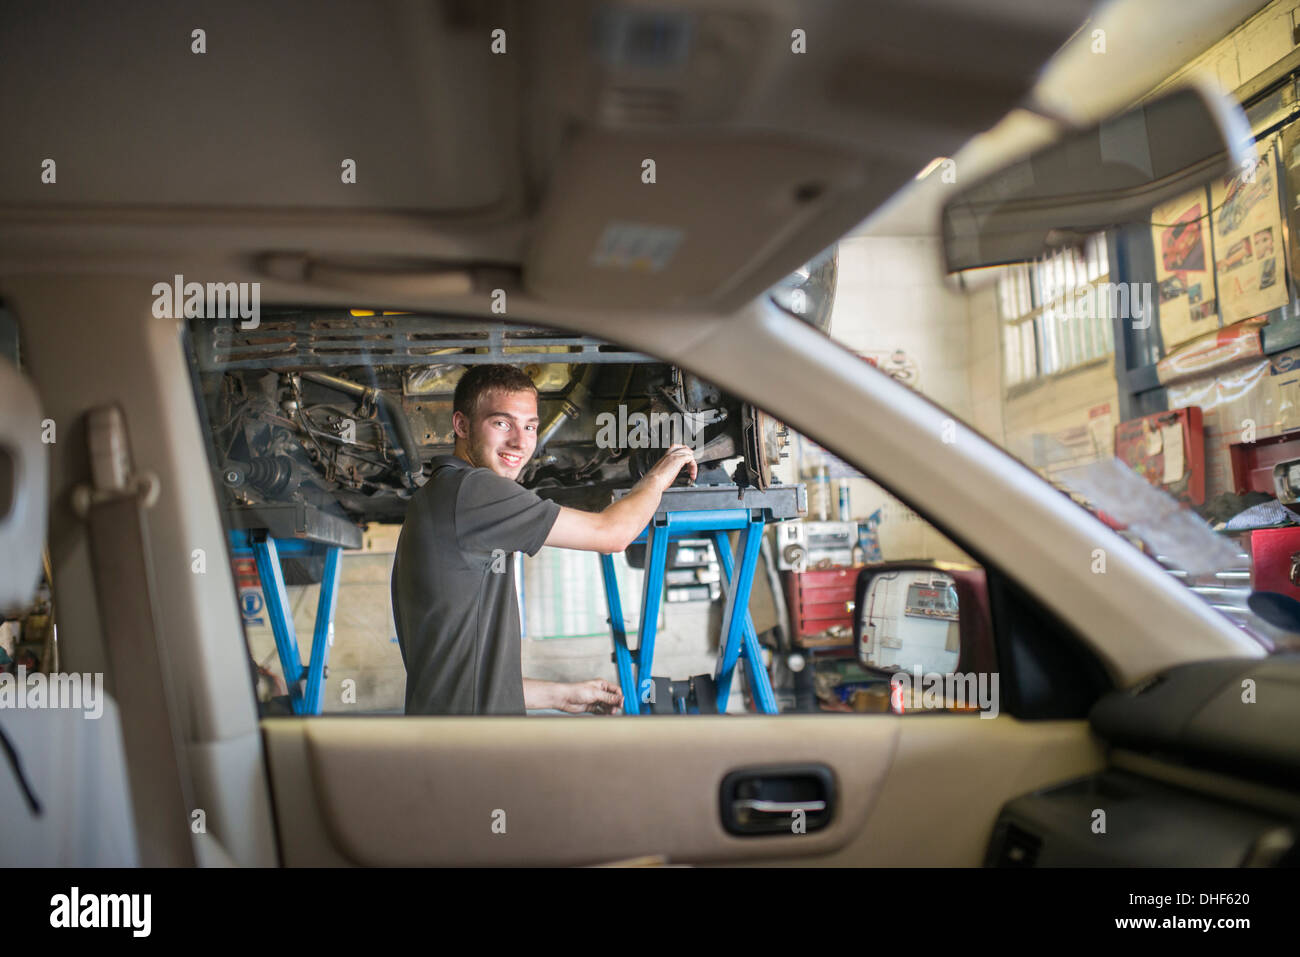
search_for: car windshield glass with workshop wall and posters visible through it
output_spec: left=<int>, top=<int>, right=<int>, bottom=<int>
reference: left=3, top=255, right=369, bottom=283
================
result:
left=827, top=67, right=1300, bottom=650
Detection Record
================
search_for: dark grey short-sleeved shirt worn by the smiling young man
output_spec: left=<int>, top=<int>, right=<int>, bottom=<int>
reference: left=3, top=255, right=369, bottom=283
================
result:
left=393, top=455, right=560, bottom=714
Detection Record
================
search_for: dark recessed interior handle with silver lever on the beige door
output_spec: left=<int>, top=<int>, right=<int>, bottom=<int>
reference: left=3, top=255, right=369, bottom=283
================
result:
left=719, top=765, right=835, bottom=836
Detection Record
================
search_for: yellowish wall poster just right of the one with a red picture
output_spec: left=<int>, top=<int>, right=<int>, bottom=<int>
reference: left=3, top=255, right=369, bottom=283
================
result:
left=1210, top=142, right=1287, bottom=322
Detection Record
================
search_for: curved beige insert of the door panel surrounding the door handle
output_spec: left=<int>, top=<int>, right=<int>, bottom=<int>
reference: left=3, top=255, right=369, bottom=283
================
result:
left=263, top=715, right=901, bottom=866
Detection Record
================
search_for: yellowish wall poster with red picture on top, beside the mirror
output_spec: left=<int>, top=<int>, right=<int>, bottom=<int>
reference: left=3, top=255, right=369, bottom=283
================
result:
left=1151, top=187, right=1219, bottom=351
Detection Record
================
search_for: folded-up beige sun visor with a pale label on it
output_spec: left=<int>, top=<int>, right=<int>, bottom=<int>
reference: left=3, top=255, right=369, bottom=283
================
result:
left=524, top=133, right=866, bottom=308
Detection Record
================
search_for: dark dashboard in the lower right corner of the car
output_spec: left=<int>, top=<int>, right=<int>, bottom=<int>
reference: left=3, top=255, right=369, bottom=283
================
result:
left=984, top=654, right=1300, bottom=867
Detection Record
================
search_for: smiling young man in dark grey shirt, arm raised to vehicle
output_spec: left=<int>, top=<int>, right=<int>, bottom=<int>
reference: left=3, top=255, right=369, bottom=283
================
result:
left=393, top=365, right=697, bottom=715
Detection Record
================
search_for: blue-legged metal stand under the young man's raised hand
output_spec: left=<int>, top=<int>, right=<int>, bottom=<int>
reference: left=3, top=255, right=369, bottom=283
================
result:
left=601, top=485, right=807, bottom=715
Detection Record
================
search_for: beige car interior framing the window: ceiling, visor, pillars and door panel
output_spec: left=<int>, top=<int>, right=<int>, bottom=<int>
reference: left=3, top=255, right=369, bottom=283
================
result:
left=0, top=0, right=1279, bottom=866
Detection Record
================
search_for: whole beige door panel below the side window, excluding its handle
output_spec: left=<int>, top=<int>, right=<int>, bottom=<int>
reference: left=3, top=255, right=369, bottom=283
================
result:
left=263, top=715, right=1102, bottom=866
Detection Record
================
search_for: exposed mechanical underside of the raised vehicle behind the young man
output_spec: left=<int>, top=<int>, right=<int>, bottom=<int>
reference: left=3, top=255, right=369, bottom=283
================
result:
left=191, top=309, right=784, bottom=535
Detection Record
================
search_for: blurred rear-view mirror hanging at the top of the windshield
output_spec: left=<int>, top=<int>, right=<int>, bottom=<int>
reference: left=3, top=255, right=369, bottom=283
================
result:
left=943, top=87, right=1253, bottom=272
